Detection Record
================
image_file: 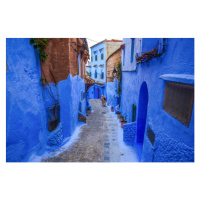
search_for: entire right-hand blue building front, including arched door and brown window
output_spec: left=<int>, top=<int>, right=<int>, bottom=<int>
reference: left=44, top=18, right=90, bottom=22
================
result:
left=121, top=38, right=194, bottom=162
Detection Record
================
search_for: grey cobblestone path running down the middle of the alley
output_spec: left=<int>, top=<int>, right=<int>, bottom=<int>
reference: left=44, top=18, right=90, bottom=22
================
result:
left=43, top=99, right=120, bottom=162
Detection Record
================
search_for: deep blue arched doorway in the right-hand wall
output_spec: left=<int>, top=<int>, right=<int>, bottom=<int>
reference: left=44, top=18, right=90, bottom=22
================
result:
left=136, top=82, right=148, bottom=160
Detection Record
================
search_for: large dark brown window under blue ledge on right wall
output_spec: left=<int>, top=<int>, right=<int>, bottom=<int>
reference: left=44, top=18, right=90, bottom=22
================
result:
left=163, top=82, right=194, bottom=127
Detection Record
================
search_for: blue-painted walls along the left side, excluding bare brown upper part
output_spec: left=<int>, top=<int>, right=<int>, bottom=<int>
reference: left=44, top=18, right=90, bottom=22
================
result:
left=6, top=38, right=86, bottom=162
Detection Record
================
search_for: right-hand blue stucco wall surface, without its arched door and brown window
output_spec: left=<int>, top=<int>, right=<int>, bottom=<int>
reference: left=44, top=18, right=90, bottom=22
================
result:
left=121, top=38, right=194, bottom=162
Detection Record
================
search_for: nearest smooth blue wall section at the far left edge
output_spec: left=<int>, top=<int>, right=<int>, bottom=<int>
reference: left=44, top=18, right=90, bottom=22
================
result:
left=6, top=38, right=47, bottom=162
